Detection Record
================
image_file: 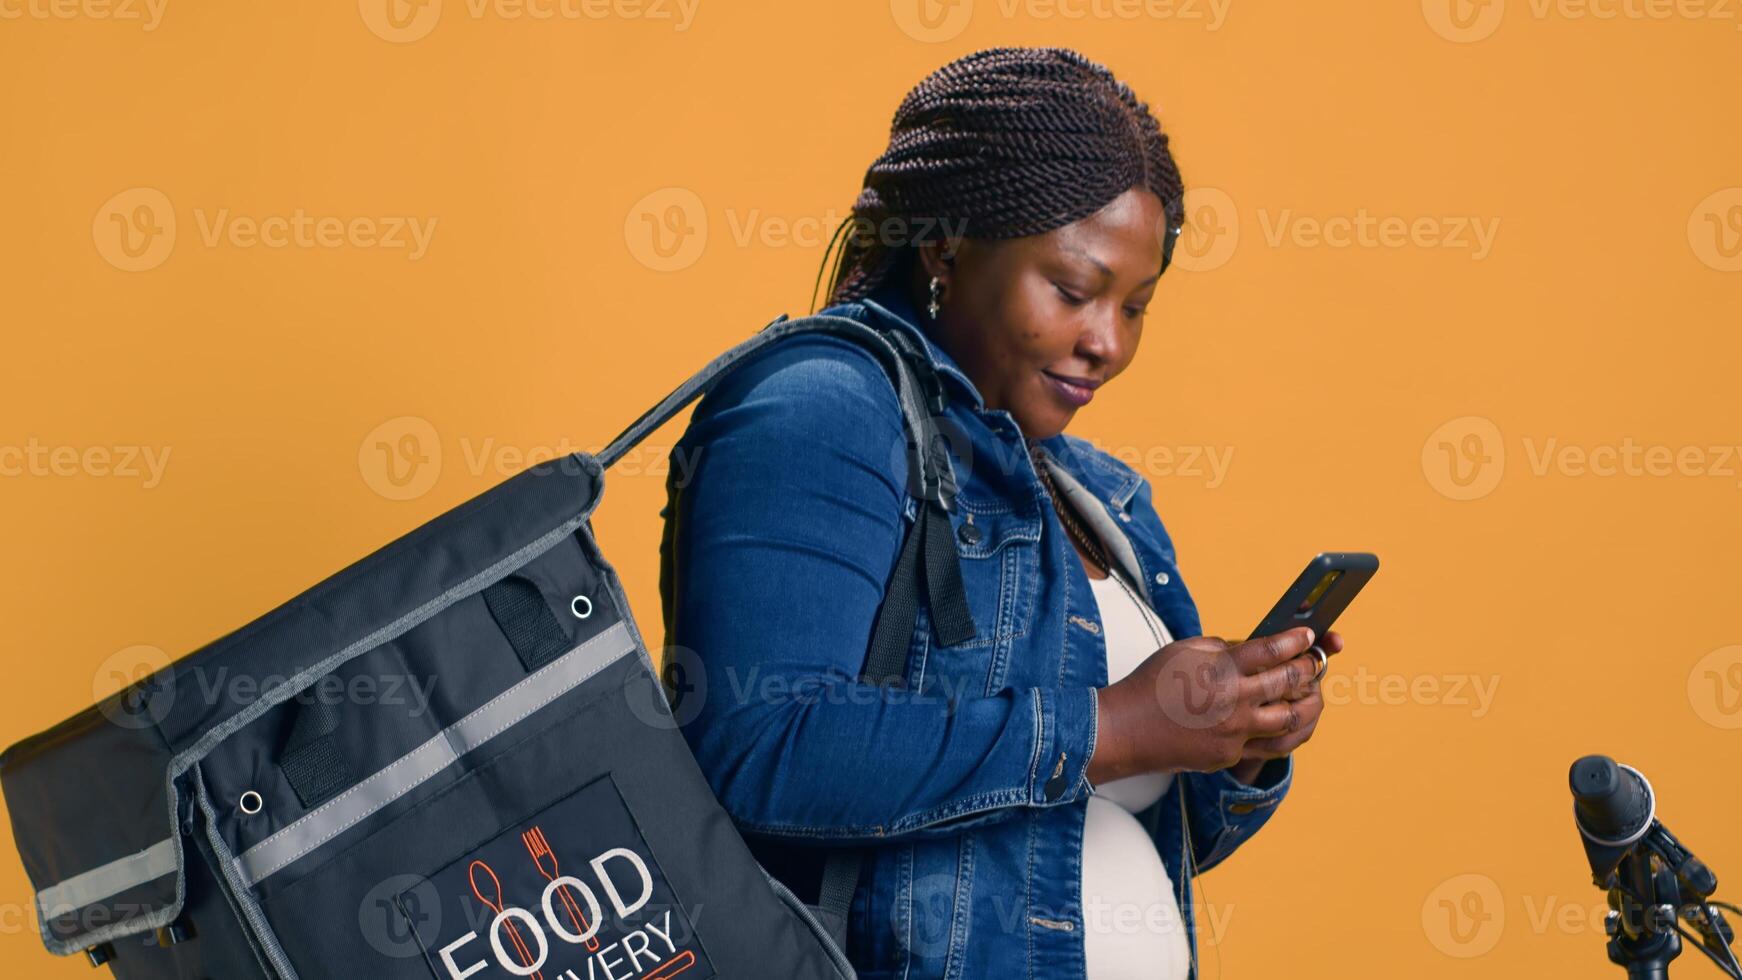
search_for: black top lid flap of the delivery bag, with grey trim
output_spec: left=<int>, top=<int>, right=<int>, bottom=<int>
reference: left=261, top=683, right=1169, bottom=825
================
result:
left=0, top=454, right=603, bottom=956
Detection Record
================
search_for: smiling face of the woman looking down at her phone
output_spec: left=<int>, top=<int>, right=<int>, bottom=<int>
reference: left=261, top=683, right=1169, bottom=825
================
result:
left=915, top=188, right=1165, bottom=439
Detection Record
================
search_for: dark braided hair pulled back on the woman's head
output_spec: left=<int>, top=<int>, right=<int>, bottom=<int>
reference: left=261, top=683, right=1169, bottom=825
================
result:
left=817, top=47, right=1185, bottom=303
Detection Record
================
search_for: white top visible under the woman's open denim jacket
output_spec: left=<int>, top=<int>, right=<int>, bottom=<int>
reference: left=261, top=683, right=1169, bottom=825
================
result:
left=1082, top=573, right=1192, bottom=980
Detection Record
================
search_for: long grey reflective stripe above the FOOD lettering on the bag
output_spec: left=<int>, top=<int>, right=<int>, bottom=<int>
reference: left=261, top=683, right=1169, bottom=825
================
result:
left=235, top=621, right=636, bottom=886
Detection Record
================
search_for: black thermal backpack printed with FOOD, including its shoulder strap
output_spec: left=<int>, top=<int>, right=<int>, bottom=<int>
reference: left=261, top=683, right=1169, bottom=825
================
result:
left=0, top=315, right=972, bottom=980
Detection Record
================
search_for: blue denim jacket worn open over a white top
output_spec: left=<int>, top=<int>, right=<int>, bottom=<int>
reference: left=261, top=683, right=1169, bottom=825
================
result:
left=660, top=276, right=1293, bottom=980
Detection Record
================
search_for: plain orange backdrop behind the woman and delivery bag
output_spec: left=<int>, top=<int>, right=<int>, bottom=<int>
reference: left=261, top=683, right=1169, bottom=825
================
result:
left=0, top=0, right=1742, bottom=978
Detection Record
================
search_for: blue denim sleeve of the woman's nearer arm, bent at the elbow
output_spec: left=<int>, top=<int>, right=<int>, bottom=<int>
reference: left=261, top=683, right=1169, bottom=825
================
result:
left=660, top=334, right=1096, bottom=844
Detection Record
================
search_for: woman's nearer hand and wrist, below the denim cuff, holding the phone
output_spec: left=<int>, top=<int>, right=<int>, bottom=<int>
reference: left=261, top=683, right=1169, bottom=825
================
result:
left=1089, top=627, right=1334, bottom=783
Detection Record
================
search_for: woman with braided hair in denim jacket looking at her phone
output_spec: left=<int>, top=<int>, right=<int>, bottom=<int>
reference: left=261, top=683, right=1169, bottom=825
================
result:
left=660, top=49, right=1341, bottom=980
